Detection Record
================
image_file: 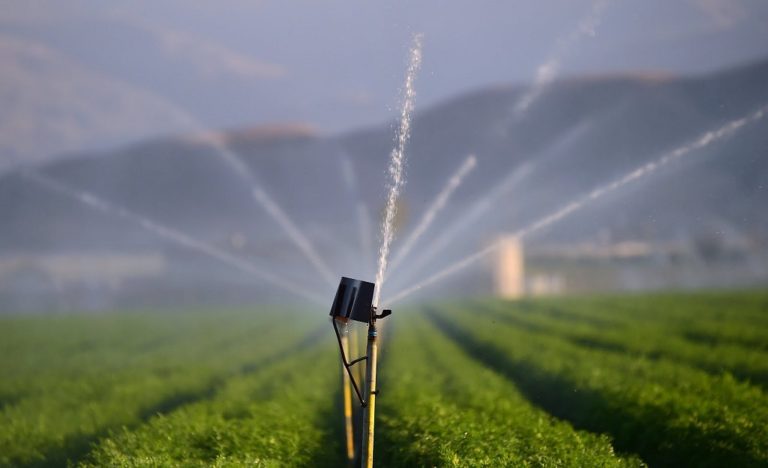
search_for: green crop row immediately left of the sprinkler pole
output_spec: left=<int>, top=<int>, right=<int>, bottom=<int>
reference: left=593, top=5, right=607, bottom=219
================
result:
left=86, top=334, right=342, bottom=466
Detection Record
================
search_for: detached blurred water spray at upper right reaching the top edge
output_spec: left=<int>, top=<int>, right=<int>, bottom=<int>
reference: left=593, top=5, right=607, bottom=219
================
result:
left=512, top=0, right=610, bottom=119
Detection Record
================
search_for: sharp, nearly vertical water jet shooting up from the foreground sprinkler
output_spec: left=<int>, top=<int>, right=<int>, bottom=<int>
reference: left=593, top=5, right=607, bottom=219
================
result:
left=373, top=34, right=423, bottom=307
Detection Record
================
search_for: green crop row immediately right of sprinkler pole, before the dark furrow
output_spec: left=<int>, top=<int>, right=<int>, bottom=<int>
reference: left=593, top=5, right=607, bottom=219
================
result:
left=378, top=314, right=642, bottom=467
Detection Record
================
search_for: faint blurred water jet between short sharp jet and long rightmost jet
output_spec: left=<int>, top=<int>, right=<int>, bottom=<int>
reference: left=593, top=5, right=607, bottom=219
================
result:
left=390, top=163, right=533, bottom=286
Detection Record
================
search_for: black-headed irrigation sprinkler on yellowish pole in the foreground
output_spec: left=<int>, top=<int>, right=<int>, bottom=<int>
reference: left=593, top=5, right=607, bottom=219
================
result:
left=330, top=277, right=392, bottom=467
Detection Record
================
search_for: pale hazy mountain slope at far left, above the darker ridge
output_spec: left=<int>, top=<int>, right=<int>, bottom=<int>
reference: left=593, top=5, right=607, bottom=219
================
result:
left=0, top=34, right=195, bottom=171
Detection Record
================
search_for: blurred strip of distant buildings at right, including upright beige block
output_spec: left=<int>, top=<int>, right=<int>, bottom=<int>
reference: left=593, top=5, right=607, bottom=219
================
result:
left=491, top=237, right=768, bottom=299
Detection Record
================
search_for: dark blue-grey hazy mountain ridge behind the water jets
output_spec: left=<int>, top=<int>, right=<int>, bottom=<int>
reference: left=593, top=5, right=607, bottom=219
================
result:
left=0, top=56, right=768, bottom=308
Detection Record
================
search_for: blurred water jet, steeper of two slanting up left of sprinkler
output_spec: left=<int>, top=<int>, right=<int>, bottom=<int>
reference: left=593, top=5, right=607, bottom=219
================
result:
left=190, top=132, right=336, bottom=285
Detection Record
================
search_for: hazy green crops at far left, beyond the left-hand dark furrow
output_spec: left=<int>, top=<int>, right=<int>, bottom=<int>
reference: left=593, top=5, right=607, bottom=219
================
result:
left=0, top=311, right=330, bottom=465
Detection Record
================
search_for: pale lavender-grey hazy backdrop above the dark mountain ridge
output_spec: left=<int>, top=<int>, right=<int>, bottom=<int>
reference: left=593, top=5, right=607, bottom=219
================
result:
left=0, top=0, right=768, bottom=167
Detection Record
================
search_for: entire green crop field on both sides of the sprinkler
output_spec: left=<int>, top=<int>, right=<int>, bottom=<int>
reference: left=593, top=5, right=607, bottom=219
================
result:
left=0, top=292, right=768, bottom=467
